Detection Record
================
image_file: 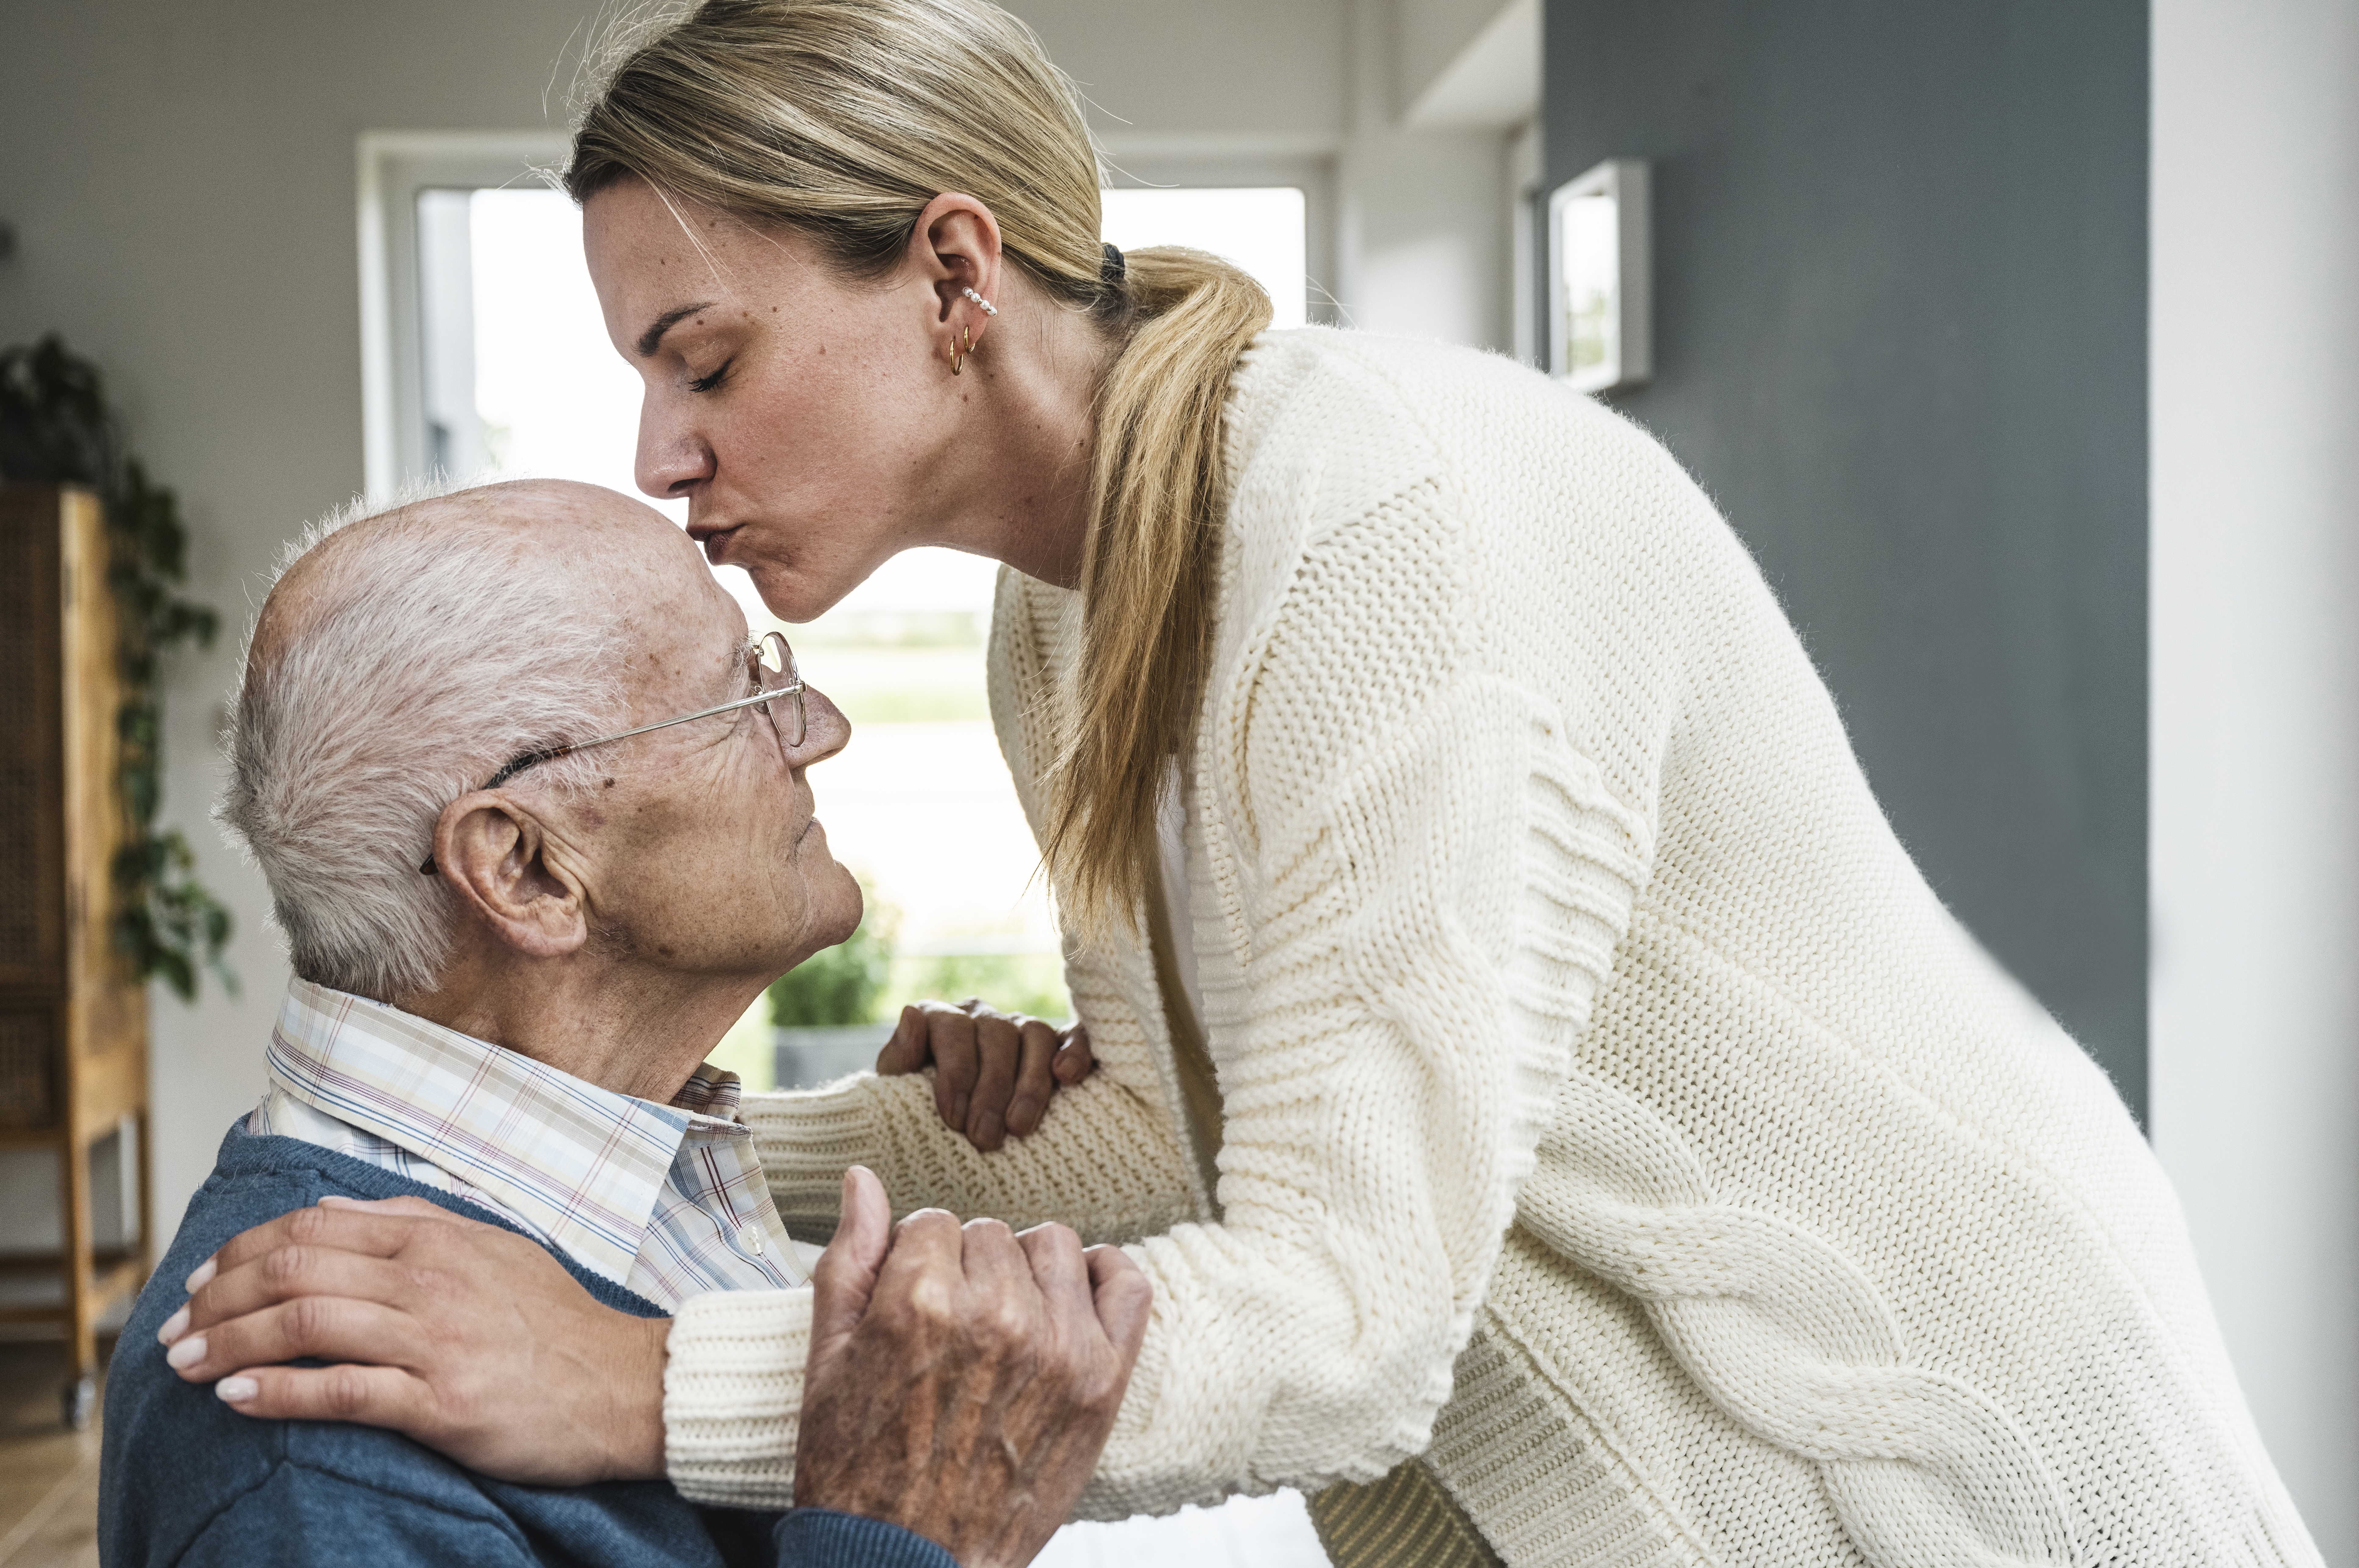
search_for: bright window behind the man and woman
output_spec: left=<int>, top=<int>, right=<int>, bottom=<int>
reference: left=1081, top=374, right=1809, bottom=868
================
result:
left=363, top=137, right=1309, bottom=1087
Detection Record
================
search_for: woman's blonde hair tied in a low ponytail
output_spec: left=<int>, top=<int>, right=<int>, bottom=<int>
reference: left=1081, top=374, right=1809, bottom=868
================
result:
left=566, top=0, right=1269, bottom=927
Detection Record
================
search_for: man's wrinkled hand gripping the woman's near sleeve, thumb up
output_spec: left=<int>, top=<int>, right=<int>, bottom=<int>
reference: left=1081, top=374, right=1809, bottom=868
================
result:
left=795, top=1167, right=1154, bottom=1568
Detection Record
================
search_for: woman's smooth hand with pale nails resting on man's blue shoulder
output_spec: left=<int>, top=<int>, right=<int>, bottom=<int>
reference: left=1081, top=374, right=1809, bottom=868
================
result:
left=158, top=1198, right=670, bottom=1486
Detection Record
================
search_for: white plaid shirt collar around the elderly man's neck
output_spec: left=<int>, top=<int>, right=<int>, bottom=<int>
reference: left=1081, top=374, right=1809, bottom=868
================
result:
left=269, top=978, right=750, bottom=1280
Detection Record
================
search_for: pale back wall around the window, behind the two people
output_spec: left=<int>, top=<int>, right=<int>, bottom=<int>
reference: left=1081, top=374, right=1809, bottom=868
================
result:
left=0, top=0, right=1505, bottom=1245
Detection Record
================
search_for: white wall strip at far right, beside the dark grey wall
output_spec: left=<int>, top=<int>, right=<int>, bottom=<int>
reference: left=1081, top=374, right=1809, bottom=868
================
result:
left=2151, top=0, right=2359, bottom=1566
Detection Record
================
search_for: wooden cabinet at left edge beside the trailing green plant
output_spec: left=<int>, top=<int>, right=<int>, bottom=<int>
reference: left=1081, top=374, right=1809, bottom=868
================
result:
left=0, top=486, right=153, bottom=1424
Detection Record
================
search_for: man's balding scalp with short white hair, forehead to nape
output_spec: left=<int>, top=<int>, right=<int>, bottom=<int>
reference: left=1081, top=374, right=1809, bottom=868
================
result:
left=215, top=481, right=743, bottom=1000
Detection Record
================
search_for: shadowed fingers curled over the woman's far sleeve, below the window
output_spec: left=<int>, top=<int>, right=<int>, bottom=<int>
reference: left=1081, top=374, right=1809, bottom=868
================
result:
left=878, top=997, right=1097, bottom=1153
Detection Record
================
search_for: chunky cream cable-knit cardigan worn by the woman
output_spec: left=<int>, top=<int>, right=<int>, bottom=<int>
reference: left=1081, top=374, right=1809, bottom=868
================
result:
left=665, top=330, right=2316, bottom=1568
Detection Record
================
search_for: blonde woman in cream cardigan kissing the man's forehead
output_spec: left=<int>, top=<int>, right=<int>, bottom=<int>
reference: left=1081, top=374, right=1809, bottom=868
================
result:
left=174, top=0, right=2316, bottom=1568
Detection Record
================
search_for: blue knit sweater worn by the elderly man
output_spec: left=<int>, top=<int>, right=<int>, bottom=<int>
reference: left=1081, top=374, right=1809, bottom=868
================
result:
left=99, top=1125, right=953, bottom=1568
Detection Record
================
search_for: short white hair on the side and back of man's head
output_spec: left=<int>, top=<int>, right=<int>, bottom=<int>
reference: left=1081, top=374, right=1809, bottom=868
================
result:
left=212, top=476, right=620, bottom=1002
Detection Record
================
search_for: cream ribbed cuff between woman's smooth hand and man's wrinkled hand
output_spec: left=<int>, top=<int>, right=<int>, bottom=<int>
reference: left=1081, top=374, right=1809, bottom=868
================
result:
left=663, top=1290, right=812, bottom=1509
